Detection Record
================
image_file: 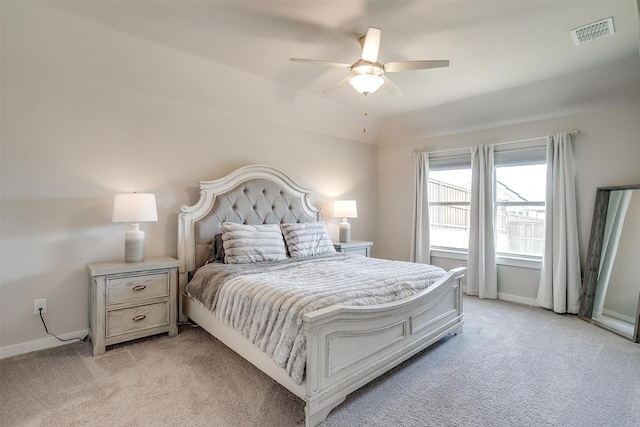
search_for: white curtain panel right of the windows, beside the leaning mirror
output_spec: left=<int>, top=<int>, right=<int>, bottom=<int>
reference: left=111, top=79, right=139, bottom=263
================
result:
left=537, top=132, right=581, bottom=313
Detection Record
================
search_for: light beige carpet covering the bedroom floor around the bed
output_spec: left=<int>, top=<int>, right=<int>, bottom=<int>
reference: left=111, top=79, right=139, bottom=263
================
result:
left=0, top=298, right=640, bottom=427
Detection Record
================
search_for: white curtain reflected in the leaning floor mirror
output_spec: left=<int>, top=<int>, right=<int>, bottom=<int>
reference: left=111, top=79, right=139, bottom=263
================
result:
left=591, top=190, right=633, bottom=319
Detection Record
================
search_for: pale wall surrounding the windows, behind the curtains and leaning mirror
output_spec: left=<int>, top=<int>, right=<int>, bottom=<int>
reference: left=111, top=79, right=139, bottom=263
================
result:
left=378, top=103, right=640, bottom=302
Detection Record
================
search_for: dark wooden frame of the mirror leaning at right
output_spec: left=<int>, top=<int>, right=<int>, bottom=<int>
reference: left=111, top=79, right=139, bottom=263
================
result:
left=578, top=184, right=640, bottom=343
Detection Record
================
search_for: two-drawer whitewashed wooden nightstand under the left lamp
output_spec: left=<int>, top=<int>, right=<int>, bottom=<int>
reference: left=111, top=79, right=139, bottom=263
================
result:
left=87, top=257, right=178, bottom=356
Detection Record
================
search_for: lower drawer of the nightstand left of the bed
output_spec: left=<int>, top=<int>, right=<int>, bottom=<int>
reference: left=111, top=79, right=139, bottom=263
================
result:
left=106, top=302, right=169, bottom=338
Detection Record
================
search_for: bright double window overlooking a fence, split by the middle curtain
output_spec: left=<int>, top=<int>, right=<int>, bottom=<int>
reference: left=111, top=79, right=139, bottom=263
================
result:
left=428, top=146, right=546, bottom=258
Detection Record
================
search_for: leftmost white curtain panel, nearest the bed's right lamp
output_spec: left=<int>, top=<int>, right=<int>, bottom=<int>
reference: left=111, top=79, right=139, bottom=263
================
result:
left=411, top=152, right=431, bottom=264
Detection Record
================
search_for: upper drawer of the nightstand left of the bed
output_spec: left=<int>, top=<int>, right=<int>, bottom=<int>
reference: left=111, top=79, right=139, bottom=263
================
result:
left=107, top=272, right=169, bottom=304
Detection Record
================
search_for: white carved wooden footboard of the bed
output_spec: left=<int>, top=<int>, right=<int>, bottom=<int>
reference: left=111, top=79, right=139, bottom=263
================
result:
left=304, top=268, right=466, bottom=426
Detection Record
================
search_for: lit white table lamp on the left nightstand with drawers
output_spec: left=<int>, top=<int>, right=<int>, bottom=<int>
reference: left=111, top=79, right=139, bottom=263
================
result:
left=112, top=193, right=158, bottom=262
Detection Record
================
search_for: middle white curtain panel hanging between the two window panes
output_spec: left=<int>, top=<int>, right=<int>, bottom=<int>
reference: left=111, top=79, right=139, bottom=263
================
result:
left=467, top=145, right=498, bottom=299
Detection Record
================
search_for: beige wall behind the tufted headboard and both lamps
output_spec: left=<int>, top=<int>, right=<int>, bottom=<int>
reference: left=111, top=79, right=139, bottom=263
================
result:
left=0, top=2, right=378, bottom=356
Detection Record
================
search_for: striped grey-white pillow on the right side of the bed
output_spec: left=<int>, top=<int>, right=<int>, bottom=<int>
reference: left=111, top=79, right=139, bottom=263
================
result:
left=280, top=222, right=336, bottom=258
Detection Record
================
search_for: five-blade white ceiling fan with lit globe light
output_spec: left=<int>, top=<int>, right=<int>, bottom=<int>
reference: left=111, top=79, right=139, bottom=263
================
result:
left=291, top=27, right=449, bottom=96
